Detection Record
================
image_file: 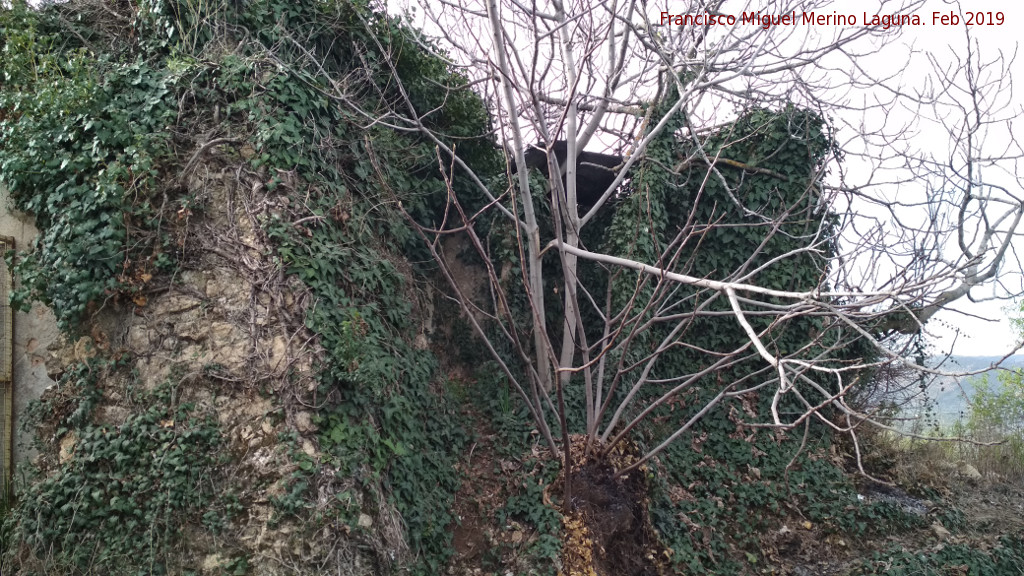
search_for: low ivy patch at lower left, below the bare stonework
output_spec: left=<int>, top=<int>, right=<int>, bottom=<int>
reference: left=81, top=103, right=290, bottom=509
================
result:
left=15, top=366, right=222, bottom=574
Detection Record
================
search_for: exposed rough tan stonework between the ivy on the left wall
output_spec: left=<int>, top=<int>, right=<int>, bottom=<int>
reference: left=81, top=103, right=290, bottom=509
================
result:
left=20, top=148, right=356, bottom=576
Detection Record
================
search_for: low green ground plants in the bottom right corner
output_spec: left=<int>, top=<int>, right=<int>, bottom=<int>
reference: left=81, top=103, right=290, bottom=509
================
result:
left=851, top=535, right=1024, bottom=576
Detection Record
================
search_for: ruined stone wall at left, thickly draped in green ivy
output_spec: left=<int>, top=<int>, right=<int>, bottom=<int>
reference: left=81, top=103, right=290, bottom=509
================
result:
left=0, top=0, right=498, bottom=574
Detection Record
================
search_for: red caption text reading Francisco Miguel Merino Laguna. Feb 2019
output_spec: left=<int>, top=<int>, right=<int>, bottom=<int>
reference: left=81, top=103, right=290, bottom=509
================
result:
left=659, top=10, right=1006, bottom=30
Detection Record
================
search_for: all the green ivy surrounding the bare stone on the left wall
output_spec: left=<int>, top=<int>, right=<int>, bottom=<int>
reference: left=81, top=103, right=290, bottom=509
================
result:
left=0, top=0, right=498, bottom=574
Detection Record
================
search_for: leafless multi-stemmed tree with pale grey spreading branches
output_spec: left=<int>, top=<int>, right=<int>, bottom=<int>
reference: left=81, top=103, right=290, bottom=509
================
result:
left=313, top=0, right=1024, bottom=491
